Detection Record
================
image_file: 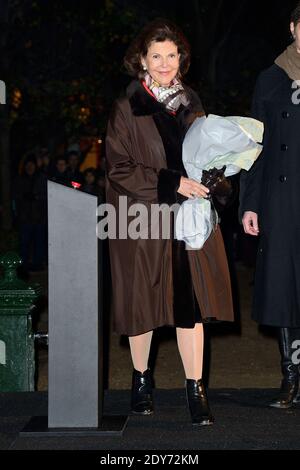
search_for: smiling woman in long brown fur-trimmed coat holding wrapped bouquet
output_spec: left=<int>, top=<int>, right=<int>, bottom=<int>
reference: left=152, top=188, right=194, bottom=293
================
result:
left=106, top=20, right=233, bottom=425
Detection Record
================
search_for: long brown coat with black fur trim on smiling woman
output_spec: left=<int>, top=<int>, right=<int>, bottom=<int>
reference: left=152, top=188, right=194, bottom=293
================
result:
left=106, top=81, right=233, bottom=336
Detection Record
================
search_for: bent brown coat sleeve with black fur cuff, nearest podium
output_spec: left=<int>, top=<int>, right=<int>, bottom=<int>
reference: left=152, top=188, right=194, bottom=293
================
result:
left=106, top=102, right=181, bottom=204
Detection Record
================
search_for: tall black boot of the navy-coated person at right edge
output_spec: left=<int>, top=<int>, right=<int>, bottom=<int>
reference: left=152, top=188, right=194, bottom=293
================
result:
left=270, top=328, right=299, bottom=409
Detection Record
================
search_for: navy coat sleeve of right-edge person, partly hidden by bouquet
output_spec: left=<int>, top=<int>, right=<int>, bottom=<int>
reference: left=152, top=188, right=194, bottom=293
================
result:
left=239, top=75, right=265, bottom=219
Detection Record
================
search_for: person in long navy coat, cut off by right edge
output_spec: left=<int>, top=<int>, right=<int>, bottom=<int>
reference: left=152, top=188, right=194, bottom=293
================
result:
left=240, top=3, right=300, bottom=408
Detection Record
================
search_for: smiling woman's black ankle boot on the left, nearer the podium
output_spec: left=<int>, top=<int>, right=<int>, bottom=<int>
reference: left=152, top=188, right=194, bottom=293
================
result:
left=131, top=369, right=153, bottom=415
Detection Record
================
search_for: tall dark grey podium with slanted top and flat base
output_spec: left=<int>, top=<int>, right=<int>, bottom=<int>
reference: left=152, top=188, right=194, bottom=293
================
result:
left=20, top=181, right=127, bottom=436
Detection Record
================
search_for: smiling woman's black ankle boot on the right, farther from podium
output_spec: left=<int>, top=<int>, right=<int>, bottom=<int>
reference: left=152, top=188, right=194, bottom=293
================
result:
left=185, top=379, right=214, bottom=426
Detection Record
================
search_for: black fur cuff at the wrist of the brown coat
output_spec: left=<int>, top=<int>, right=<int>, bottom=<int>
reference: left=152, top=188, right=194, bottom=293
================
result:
left=157, top=168, right=182, bottom=204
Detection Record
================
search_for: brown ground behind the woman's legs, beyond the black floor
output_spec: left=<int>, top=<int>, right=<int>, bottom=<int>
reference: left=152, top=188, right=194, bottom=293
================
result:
left=31, top=265, right=280, bottom=390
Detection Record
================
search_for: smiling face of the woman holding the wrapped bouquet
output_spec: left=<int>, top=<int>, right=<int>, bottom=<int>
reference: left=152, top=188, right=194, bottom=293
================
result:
left=141, top=41, right=180, bottom=86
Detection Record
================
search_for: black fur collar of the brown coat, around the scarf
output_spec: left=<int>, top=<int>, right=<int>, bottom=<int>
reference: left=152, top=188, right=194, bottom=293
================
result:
left=126, top=80, right=199, bottom=116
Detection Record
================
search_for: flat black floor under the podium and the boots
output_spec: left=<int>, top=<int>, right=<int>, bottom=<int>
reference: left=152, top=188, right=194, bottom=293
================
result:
left=0, top=388, right=300, bottom=452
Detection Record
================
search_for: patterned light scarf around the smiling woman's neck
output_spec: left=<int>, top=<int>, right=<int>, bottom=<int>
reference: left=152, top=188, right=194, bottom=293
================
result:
left=145, top=73, right=189, bottom=112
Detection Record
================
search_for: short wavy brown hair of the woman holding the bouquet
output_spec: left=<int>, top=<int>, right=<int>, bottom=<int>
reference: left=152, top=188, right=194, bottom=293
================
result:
left=124, top=18, right=191, bottom=78
